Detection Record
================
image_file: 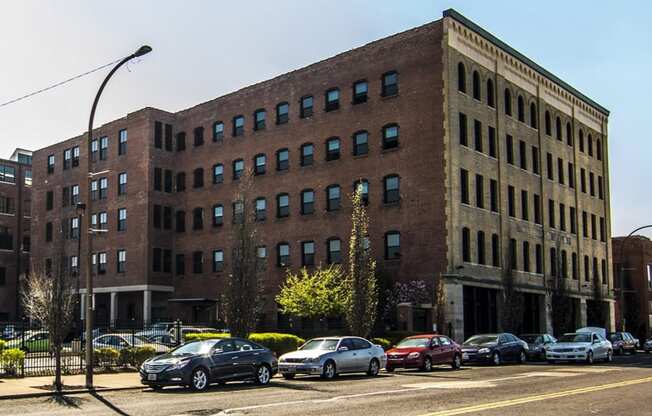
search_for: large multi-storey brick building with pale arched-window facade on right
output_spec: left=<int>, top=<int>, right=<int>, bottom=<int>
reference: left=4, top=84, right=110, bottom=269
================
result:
left=33, top=10, right=613, bottom=339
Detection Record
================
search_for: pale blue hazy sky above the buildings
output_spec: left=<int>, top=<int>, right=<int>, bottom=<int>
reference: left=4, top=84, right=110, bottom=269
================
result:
left=0, top=0, right=652, bottom=236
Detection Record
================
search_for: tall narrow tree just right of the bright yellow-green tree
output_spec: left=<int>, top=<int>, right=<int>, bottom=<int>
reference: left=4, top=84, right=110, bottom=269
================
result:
left=346, top=188, right=378, bottom=337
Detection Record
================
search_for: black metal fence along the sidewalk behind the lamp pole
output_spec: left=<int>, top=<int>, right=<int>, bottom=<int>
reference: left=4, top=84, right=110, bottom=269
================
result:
left=0, top=321, right=225, bottom=377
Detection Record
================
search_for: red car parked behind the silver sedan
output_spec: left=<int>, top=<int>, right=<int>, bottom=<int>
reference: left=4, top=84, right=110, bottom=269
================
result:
left=385, top=334, right=462, bottom=372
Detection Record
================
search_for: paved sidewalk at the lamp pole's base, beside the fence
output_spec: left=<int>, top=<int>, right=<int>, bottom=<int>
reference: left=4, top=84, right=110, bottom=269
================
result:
left=0, top=372, right=145, bottom=400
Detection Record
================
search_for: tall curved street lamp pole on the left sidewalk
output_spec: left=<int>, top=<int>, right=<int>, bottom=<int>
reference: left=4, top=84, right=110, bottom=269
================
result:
left=79, top=45, right=152, bottom=389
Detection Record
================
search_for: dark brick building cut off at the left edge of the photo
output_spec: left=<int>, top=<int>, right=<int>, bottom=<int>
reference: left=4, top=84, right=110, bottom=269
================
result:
left=0, top=149, right=32, bottom=322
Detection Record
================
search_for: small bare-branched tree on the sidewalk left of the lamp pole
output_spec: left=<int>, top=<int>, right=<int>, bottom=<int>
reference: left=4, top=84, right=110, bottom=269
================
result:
left=22, top=255, right=77, bottom=393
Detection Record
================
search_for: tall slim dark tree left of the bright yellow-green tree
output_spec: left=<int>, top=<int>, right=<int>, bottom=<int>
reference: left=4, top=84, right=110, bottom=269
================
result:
left=223, top=171, right=264, bottom=338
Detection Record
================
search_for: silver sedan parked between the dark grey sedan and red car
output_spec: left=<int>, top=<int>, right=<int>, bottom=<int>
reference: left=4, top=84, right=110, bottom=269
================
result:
left=279, top=337, right=387, bottom=379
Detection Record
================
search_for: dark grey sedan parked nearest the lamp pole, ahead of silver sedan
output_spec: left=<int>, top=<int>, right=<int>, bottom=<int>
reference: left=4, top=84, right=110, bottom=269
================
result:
left=140, top=338, right=278, bottom=391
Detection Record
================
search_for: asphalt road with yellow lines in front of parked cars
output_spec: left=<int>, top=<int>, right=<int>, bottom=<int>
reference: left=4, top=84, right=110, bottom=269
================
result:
left=5, top=353, right=652, bottom=416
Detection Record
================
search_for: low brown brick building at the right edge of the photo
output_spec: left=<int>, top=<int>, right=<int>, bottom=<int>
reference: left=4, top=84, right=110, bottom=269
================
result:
left=612, top=235, right=652, bottom=341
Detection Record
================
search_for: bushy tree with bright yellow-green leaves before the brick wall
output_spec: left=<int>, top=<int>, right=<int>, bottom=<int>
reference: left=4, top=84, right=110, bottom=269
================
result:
left=276, top=264, right=346, bottom=319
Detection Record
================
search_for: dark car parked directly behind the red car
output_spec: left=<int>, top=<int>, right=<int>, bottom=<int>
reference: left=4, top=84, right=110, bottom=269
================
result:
left=462, top=333, right=527, bottom=365
